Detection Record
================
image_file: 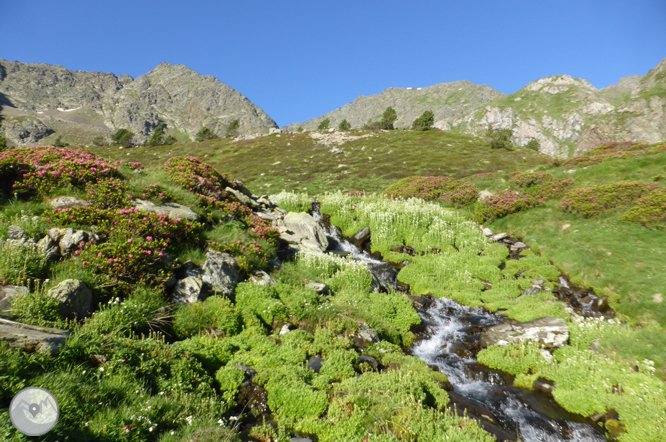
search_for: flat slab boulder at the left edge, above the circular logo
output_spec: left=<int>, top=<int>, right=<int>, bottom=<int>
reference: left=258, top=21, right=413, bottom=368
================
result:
left=0, top=319, right=69, bottom=356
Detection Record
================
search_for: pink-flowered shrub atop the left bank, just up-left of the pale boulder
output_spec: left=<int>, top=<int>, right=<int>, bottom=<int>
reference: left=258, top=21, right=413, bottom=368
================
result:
left=164, top=157, right=236, bottom=198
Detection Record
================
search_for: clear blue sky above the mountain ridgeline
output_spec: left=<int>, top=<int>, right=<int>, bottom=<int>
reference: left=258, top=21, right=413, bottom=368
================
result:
left=0, top=0, right=666, bottom=126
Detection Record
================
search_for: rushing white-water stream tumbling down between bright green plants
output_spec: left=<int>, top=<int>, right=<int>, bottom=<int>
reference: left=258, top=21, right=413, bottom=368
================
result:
left=313, top=208, right=607, bottom=442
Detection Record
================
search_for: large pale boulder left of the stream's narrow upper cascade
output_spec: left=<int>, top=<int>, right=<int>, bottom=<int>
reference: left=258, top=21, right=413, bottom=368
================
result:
left=277, top=212, right=328, bottom=253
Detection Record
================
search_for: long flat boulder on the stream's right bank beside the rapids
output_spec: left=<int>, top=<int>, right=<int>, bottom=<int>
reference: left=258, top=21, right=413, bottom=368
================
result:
left=479, top=318, right=569, bottom=348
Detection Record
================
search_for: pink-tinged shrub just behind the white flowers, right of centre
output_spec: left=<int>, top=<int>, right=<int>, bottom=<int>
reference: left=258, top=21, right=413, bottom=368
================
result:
left=384, top=176, right=479, bottom=207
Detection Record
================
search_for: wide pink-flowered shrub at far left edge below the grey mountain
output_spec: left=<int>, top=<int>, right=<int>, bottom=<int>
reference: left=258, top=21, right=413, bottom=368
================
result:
left=0, top=146, right=120, bottom=195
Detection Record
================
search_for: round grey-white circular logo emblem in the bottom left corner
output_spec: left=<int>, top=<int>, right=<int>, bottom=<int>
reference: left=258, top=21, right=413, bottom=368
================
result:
left=9, top=387, right=60, bottom=436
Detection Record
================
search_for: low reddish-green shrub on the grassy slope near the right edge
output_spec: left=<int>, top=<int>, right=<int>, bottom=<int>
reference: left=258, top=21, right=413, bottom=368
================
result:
left=560, top=181, right=659, bottom=218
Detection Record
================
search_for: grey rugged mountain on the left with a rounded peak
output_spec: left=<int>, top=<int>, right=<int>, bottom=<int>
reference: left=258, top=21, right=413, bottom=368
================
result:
left=0, top=60, right=277, bottom=145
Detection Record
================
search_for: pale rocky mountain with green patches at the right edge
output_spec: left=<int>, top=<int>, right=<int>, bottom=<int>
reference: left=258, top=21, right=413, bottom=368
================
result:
left=452, top=59, right=666, bottom=157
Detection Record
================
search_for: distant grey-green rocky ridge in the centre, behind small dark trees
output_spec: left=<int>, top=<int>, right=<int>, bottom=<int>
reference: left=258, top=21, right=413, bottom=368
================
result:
left=282, top=81, right=505, bottom=132
